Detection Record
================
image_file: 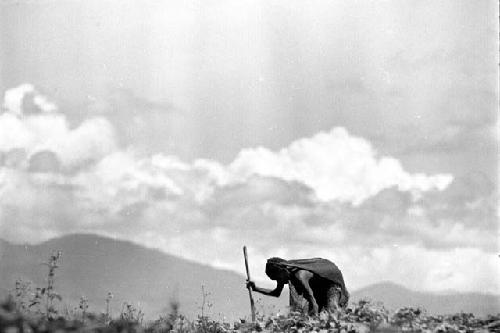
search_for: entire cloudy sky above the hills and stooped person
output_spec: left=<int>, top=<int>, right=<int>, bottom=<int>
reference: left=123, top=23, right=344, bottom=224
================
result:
left=0, top=0, right=500, bottom=293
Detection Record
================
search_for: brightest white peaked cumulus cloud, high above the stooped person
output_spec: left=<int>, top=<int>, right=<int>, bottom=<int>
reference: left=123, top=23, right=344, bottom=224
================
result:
left=230, top=128, right=453, bottom=204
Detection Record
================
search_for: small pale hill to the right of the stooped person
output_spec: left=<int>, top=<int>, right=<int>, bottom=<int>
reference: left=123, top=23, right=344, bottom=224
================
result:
left=351, top=282, right=500, bottom=316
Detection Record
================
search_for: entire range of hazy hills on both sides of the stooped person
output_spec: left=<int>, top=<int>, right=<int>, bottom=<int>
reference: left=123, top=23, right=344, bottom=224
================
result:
left=0, top=235, right=500, bottom=320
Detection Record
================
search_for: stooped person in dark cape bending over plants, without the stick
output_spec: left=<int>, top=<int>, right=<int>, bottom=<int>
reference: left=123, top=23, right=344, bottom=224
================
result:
left=247, top=258, right=349, bottom=315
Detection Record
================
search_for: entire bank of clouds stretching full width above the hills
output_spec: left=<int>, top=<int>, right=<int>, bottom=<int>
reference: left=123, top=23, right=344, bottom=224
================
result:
left=0, top=85, right=500, bottom=292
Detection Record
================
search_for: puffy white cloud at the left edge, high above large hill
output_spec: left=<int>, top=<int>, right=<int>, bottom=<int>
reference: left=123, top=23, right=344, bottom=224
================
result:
left=0, top=84, right=117, bottom=170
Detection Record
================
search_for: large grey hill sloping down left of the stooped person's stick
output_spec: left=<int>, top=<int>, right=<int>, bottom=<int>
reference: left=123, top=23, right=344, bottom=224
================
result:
left=0, top=234, right=278, bottom=318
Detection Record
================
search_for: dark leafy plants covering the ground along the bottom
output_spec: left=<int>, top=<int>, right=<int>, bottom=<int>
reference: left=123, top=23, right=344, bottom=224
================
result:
left=0, top=252, right=500, bottom=333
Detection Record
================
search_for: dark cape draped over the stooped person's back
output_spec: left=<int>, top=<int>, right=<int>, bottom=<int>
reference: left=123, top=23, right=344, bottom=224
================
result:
left=280, top=258, right=349, bottom=306
